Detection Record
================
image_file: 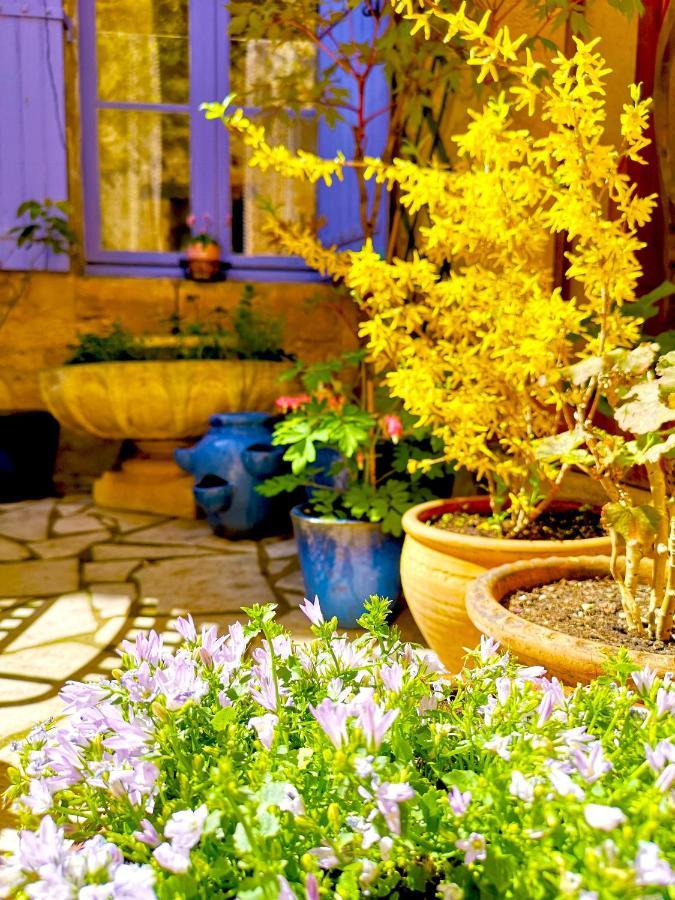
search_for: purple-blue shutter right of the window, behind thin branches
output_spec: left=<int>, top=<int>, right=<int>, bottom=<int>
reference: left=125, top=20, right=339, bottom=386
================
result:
left=318, top=0, right=389, bottom=252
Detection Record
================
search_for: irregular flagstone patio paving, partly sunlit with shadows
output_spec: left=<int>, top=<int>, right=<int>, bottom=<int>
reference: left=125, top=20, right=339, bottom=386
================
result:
left=0, top=495, right=421, bottom=828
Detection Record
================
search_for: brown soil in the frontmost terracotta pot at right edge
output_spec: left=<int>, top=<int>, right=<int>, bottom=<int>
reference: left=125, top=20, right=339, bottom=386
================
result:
left=503, top=576, right=675, bottom=655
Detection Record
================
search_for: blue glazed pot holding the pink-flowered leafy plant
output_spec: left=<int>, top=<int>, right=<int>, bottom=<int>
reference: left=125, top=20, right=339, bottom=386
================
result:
left=291, top=506, right=403, bottom=628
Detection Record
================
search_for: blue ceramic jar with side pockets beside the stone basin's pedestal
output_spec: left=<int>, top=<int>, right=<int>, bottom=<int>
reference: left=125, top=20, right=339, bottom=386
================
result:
left=174, top=412, right=288, bottom=538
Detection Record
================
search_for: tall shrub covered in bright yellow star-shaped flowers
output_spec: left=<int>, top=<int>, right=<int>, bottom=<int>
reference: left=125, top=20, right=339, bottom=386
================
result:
left=208, top=0, right=655, bottom=536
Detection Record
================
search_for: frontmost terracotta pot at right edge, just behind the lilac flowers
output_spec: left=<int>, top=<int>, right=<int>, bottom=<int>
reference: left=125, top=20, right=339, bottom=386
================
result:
left=466, top=556, right=675, bottom=684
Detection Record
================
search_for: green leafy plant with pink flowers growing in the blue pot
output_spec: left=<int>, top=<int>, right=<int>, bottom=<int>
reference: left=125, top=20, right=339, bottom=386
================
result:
left=257, top=350, right=450, bottom=536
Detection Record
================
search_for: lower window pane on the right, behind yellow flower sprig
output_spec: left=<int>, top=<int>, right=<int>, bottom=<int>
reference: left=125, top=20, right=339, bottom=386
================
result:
left=230, top=118, right=316, bottom=256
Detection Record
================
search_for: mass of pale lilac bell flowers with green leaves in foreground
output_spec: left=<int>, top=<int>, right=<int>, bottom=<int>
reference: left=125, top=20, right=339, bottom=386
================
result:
left=0, top=598, right=675, bottom=900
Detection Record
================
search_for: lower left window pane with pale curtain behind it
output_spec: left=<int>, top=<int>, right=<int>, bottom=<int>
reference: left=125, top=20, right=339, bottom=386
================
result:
left=98, top=109, right=190, bottom=252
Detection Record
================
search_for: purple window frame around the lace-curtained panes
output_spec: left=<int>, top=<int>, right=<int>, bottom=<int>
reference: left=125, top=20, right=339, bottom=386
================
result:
left=79, top=0, right=319, bottom=281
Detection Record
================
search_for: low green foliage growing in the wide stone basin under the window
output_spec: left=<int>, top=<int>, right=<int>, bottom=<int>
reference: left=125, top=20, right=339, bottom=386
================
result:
left=68, top=284, right=291, bottom=365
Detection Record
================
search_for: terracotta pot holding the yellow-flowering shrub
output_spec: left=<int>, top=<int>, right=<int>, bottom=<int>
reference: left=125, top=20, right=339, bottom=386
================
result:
left=401, top=497, right=610, bottom=672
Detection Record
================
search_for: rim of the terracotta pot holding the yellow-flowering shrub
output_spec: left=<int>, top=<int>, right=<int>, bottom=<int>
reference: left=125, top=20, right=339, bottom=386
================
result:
left=402, top=496, right=609, bottom=557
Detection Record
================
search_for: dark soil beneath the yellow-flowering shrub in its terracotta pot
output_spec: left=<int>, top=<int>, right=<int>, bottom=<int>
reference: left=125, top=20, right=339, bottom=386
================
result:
left=427, top=505, right=605, bottom=541
